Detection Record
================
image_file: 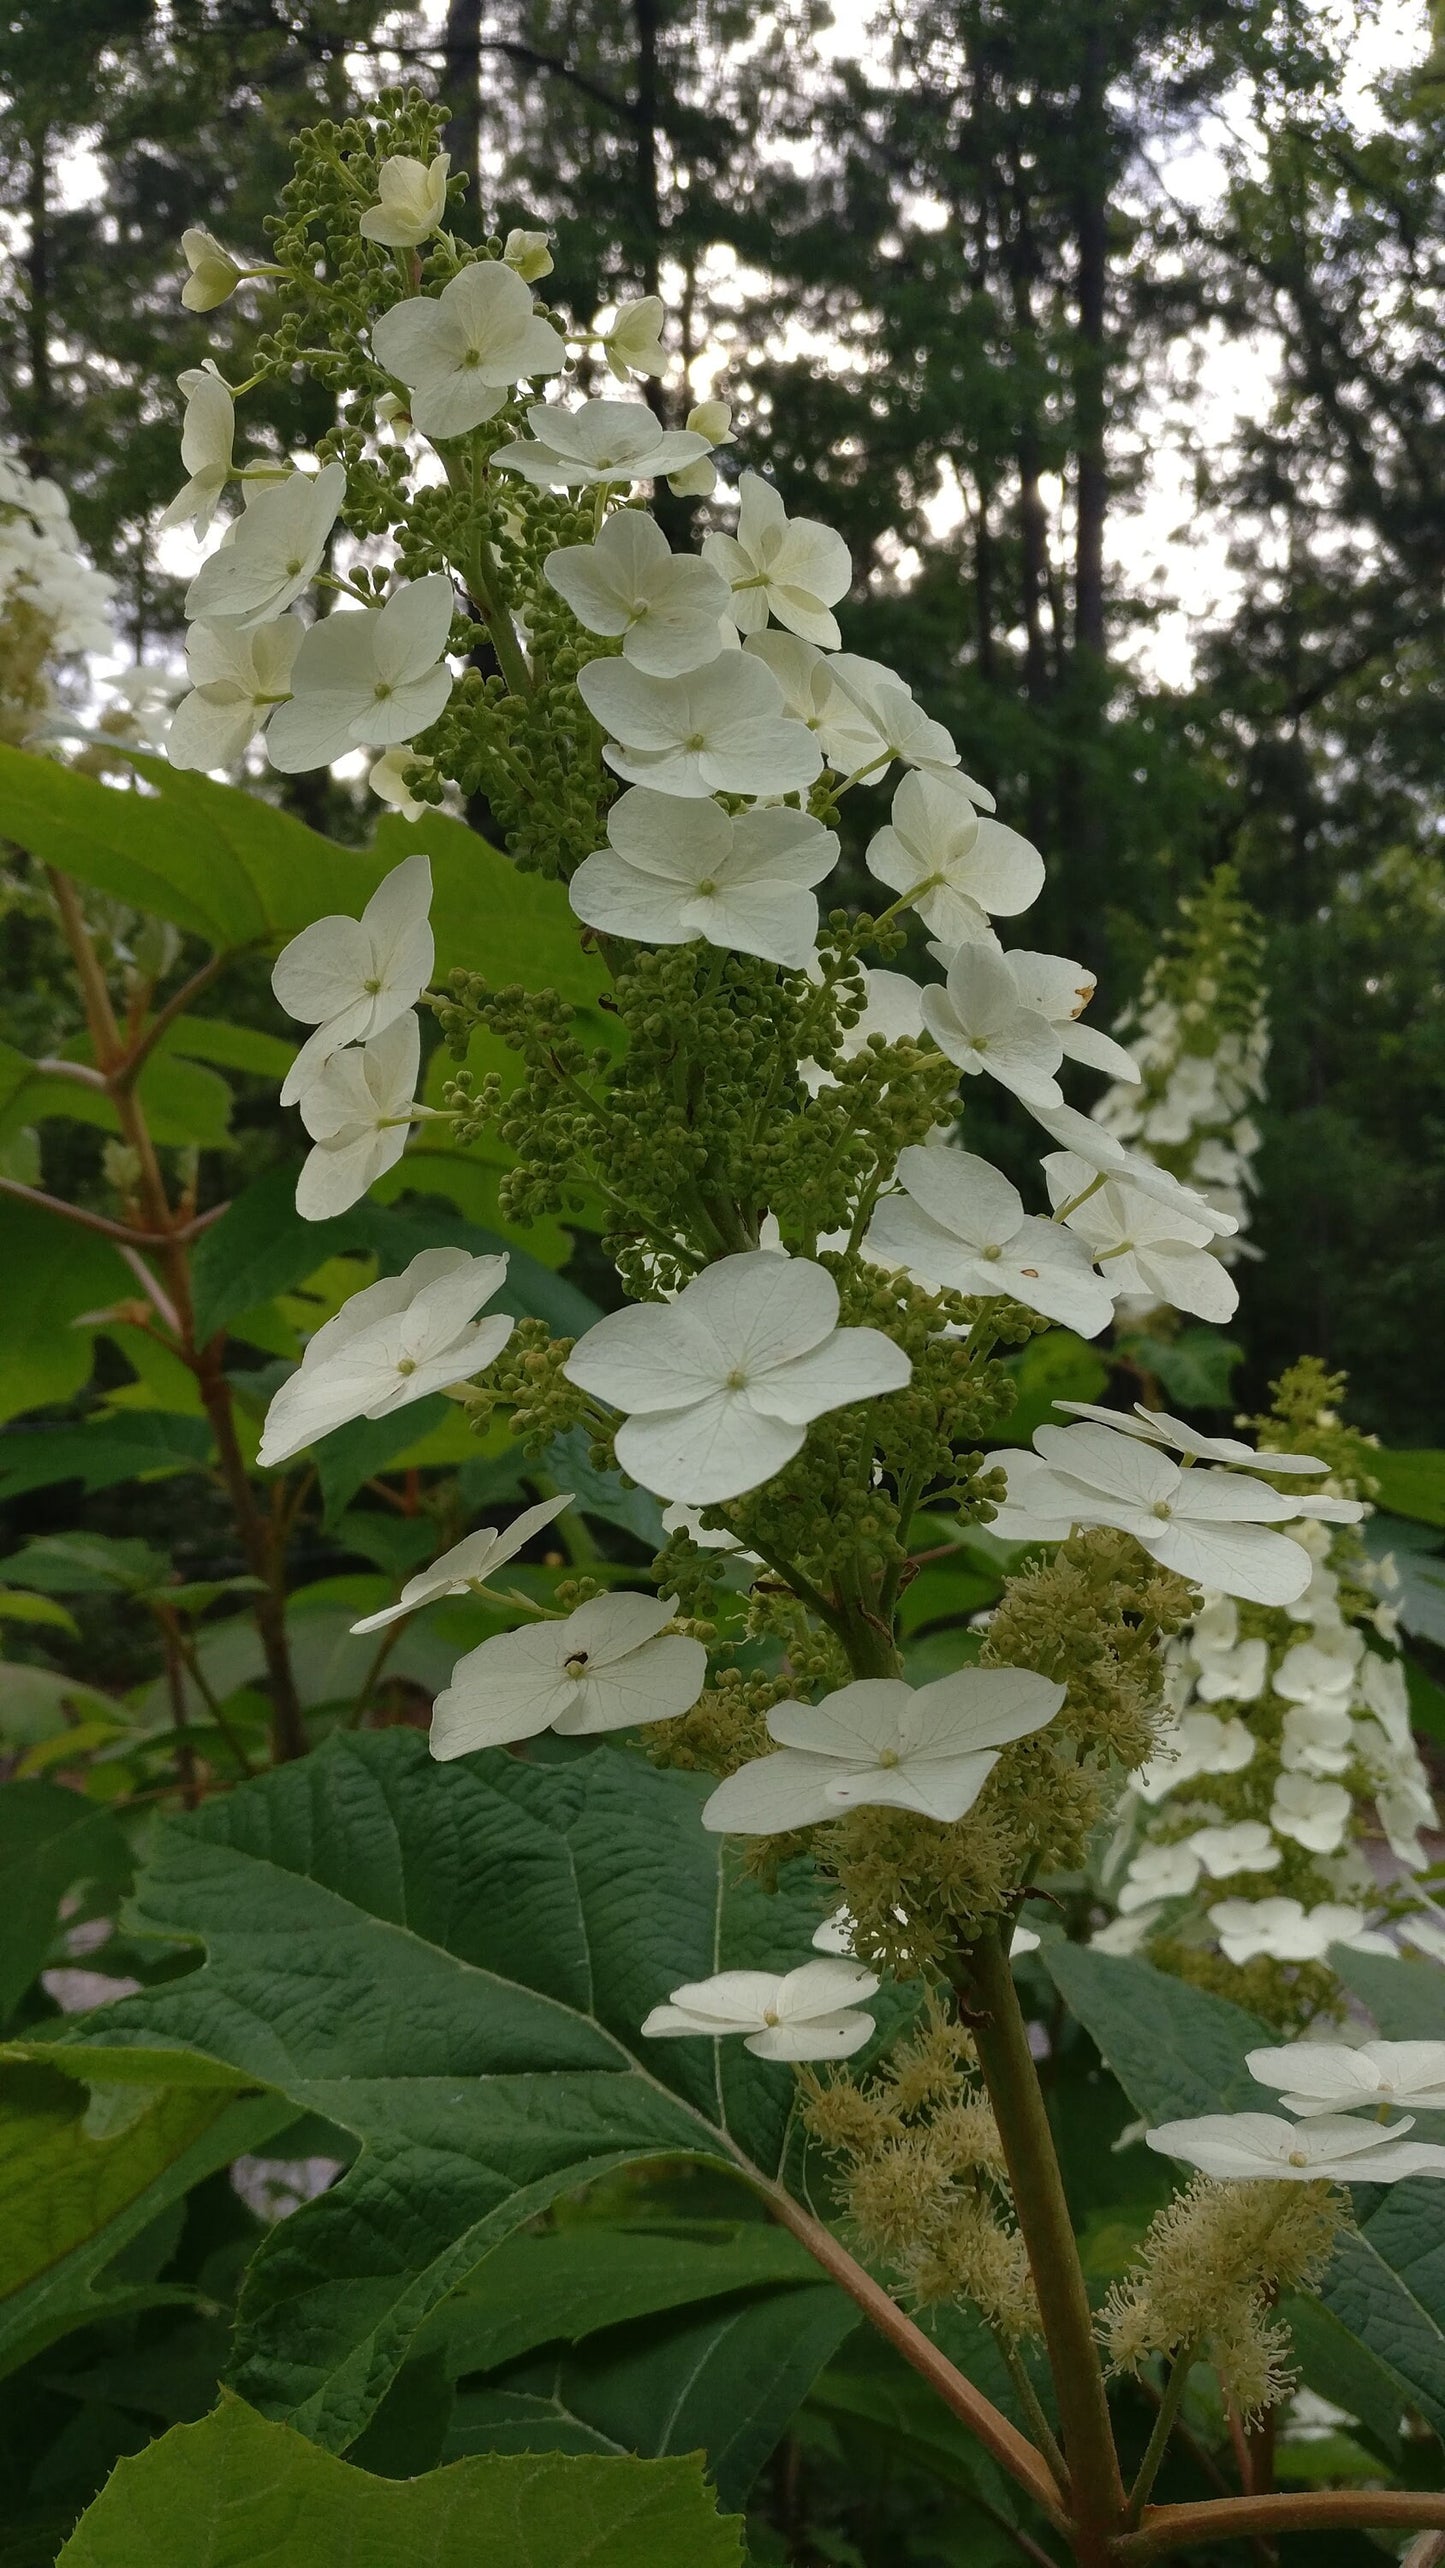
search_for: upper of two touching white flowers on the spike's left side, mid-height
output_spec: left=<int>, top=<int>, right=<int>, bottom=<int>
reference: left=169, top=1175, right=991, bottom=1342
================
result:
left=272, top=855, right=436, bottom=1107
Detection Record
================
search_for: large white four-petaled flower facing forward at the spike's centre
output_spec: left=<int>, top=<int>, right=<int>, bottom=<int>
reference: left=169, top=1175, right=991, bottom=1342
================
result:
left=565, top=1248, right=911, bottom=1507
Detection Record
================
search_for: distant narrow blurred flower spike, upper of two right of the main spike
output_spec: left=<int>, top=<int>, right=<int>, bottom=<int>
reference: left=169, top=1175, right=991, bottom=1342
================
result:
left=1093, top=865, right=1270, bottom=1273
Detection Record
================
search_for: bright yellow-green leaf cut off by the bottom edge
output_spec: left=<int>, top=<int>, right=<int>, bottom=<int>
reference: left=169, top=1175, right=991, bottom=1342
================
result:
left=56, top=2399, right=742, bottom=2568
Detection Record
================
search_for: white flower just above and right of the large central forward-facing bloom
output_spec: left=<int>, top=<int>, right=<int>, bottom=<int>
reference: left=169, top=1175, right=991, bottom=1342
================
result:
left=862, top=1145, right=1114, bottom=1338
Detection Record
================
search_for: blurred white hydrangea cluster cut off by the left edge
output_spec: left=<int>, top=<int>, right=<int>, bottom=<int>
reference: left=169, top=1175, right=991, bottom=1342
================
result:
left=0, top=442, right=115, bottom=747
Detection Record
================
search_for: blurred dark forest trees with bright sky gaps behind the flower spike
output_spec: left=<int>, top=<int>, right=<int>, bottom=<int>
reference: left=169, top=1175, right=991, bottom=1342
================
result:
left=0, top=0, right=1445, bottom=1443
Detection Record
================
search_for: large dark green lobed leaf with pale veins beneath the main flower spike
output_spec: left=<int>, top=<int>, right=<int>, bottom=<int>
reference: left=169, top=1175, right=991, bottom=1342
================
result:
left=51, top=1731, right=846, bottom=2450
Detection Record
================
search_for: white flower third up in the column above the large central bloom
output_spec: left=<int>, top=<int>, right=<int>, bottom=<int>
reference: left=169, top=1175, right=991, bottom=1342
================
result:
left=542, top=508, right=726, bottom=678
